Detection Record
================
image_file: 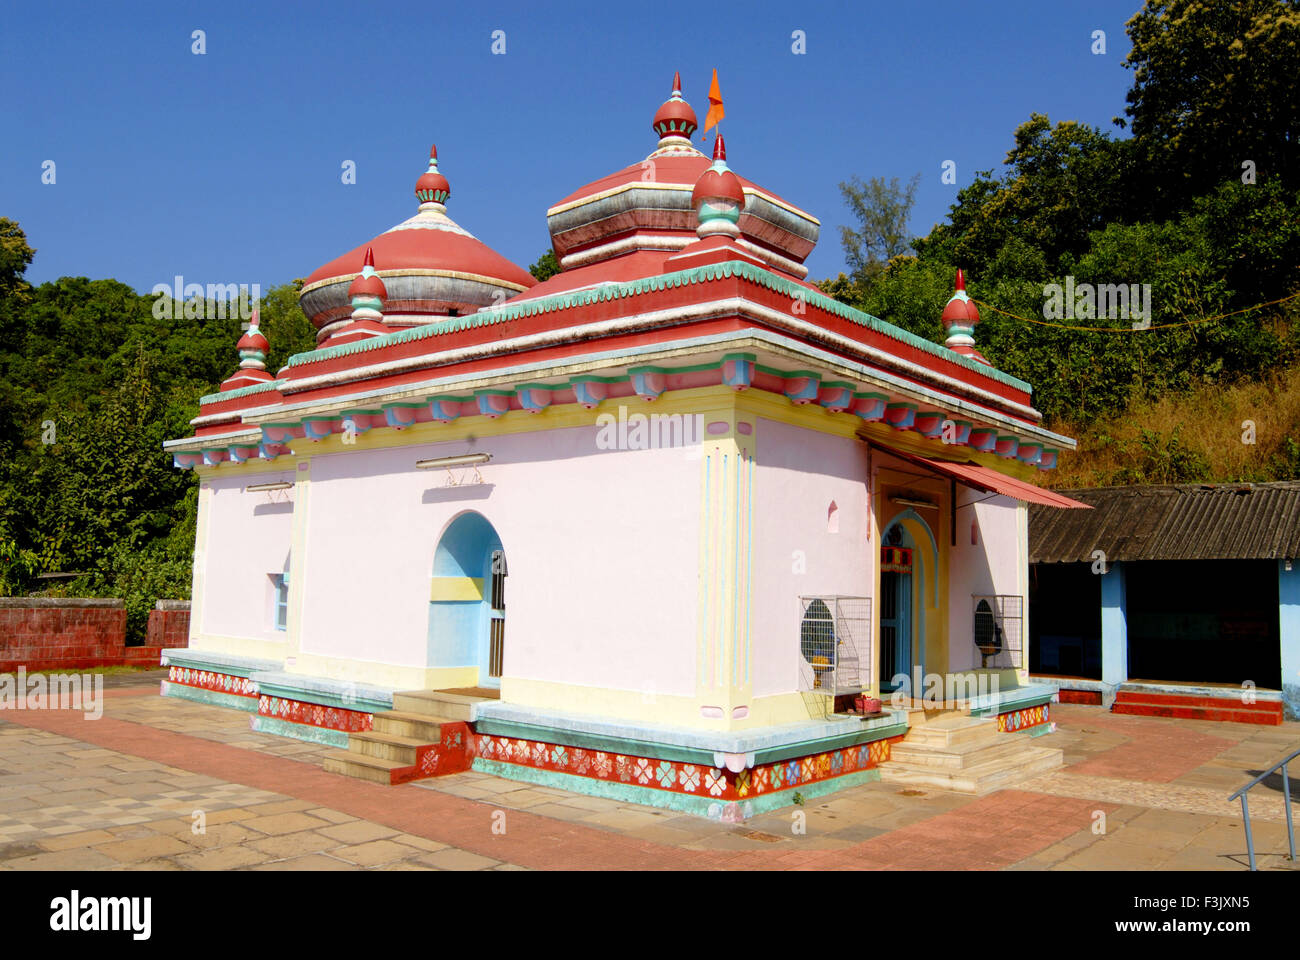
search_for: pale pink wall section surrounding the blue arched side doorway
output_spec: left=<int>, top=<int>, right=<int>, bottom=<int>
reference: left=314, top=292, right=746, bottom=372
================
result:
left=302, top=427, right=699, bottom=696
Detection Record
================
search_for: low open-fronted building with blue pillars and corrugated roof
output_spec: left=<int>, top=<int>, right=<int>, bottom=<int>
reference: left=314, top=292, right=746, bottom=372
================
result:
left=1030, top=481, right=1300, bottom=723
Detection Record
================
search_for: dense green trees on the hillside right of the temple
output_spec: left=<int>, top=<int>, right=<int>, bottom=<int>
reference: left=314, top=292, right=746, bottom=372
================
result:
left=822, top=0, right=1300, bottom=444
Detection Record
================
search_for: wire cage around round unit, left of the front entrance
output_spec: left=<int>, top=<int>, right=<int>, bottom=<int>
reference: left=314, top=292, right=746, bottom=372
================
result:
left=800, top=596, right=871, bottom=717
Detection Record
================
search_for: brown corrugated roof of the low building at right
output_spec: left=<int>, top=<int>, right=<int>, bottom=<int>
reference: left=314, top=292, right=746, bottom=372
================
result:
left=1030, top=480, right=1300, bottom=563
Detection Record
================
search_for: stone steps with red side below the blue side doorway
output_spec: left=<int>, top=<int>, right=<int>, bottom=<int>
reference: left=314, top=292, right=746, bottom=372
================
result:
left=324, top=691, right=484, bottom=784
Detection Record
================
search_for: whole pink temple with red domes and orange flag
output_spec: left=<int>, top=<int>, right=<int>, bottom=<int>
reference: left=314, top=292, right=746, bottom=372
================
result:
left=164, top=78, right=1082, bottom=820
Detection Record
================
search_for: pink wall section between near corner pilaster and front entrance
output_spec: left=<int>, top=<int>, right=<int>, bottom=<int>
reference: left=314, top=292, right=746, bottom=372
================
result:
left=751, top=420, right=872, bottom=697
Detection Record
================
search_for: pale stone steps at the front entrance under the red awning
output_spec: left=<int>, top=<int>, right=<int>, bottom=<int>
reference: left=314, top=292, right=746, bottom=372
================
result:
left=880, top=713, right=1065, bottom=796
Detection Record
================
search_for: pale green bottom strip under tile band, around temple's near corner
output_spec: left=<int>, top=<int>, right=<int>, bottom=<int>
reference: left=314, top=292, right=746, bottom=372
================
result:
left=471, top=757, right=880, bottom=820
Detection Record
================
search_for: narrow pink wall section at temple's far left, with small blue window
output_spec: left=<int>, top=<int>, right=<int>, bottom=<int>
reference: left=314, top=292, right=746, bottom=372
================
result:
left=191, top=470, right=294, bottom=641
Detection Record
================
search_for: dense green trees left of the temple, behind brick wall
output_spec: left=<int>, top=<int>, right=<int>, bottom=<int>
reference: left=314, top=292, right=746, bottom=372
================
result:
left=0, top=234, right=315, bottom=637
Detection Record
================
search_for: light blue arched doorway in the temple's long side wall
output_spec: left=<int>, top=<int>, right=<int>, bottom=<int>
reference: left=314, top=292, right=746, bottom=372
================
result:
left=429, top=511, right=507, bottom=688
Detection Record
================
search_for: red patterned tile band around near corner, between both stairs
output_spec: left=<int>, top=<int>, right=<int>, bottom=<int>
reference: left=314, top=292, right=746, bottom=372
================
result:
left=476, top=734, right=902, bottom=803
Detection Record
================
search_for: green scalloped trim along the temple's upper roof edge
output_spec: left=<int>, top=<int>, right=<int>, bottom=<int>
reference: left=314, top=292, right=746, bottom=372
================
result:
left=287, top=260, right=1032, bottom=399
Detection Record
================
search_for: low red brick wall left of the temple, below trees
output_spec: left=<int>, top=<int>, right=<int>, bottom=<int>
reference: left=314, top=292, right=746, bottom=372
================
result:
left=0, top=597, right=190, bottom=673
